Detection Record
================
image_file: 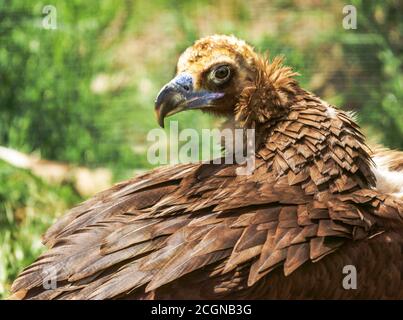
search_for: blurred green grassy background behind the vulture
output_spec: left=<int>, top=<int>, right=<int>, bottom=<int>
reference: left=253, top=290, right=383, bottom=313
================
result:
left=0, top=0, right=403, bottom=297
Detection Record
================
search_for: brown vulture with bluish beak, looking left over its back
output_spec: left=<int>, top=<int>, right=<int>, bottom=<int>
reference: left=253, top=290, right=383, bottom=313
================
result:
left=11, top=35, right=403, bottom=299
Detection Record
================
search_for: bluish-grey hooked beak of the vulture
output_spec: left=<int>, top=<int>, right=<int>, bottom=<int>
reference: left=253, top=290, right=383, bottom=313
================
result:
left=155, top=73, right=224, bottom=128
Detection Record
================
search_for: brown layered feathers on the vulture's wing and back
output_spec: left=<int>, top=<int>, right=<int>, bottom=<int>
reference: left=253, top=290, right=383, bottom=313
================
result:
left=13, top=96, right=403, bottom=299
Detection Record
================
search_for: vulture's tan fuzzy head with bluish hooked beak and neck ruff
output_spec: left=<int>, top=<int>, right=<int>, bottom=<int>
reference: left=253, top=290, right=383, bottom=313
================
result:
left=155, top=35, right=302, bottom=127
